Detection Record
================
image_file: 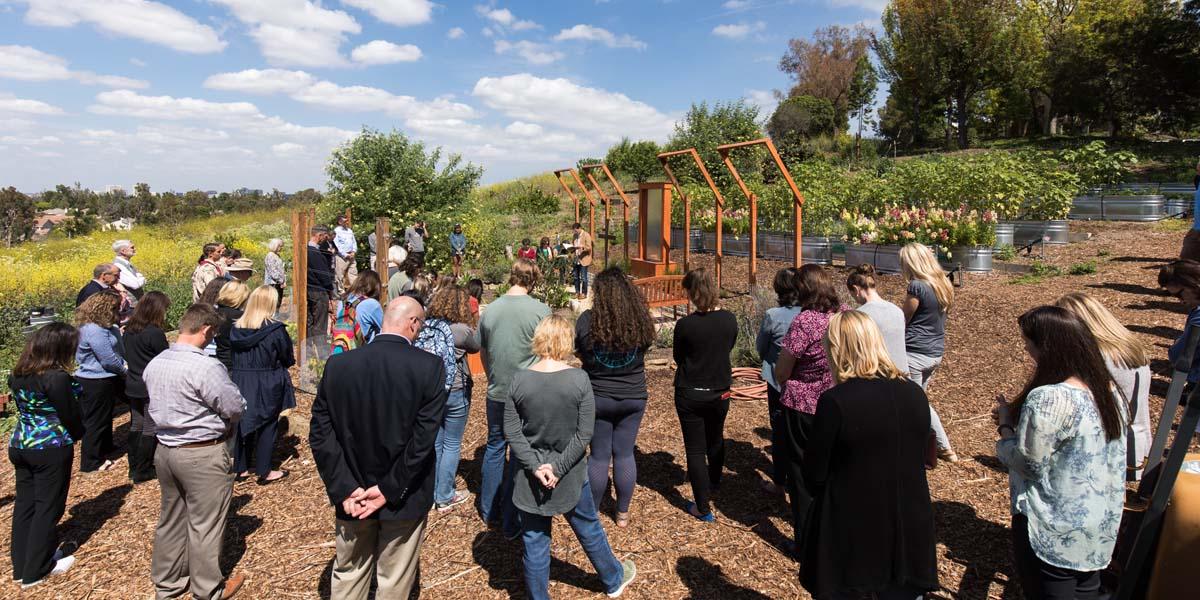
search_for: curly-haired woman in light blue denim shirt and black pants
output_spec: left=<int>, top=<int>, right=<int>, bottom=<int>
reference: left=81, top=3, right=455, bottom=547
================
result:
left=74, top=289, right=126, bottom=473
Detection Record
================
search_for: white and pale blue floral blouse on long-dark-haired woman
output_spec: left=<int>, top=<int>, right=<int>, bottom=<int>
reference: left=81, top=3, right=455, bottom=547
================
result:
left=996, top=383, right=1126, bottom=572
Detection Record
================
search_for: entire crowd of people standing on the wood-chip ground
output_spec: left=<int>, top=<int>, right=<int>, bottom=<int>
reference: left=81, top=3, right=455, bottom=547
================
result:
left=0, top=220, right=1180, bottom=599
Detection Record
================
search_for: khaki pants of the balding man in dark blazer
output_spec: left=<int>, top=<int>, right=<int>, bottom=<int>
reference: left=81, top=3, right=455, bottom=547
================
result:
left=330, top=517, right=425, bottom=600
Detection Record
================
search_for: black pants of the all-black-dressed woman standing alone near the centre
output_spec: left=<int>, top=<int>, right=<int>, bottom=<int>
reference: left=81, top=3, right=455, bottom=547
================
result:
left=676, top=388, right=730, bottom=514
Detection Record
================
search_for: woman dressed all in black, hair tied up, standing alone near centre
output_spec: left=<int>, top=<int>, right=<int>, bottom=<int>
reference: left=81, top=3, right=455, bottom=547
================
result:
left=673, top=269, right=738, bottom=521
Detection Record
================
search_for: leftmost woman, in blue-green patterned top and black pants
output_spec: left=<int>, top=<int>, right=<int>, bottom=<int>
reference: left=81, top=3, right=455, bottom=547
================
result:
left=8, top=323, right=84, bottom=588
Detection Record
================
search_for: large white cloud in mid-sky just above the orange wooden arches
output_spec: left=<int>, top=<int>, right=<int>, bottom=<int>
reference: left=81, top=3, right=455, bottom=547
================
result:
left=472, top=73, right=674, bottom=139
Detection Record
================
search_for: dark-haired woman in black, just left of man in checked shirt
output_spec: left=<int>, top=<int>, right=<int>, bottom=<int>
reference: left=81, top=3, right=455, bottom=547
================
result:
left=125, top=292, right=170, bottom=484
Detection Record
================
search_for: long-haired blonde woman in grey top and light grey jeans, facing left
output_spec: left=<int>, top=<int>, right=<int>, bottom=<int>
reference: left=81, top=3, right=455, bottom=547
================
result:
left=900, top=244, right=959, bottom=462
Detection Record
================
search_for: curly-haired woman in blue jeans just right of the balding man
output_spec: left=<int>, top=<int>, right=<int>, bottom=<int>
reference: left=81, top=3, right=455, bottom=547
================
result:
left=426, top=286, right=479, bottom=511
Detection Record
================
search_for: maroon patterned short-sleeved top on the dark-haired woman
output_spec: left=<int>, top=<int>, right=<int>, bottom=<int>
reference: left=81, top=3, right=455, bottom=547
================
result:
left=780, top=305, right=850, bottom=414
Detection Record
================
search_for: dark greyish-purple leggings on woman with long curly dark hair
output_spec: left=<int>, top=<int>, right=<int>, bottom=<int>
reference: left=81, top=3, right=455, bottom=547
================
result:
left=588, top=395, right=646, bottom=512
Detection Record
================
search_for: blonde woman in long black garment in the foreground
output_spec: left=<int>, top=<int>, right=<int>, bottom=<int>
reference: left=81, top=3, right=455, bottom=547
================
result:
left=800, top=311, right=938, bottom=599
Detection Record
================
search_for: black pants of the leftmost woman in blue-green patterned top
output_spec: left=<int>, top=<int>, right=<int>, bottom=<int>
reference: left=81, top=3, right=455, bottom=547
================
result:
left=8, top=445, right=74, bottom=583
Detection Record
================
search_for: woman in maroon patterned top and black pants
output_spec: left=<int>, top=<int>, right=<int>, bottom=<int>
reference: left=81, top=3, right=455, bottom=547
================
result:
left=775, top=264, right=848, bottom=550
